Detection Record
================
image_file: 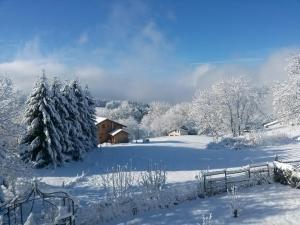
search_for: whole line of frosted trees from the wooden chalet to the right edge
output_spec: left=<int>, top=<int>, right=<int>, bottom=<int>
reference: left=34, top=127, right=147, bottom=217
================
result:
left=98, top=55, right=300, bottom=138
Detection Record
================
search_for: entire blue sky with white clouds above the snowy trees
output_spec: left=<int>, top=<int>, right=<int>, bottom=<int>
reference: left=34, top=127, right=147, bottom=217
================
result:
left=0, top=0, right=300, bottom=101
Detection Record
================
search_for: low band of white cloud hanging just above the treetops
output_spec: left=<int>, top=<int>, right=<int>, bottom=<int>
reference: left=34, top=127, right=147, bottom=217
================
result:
left=0, top=40, right=294, bottom=102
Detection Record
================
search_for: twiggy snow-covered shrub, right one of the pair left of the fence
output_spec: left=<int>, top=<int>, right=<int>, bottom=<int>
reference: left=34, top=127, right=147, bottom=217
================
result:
left=140, top=161, right=167, bottom=194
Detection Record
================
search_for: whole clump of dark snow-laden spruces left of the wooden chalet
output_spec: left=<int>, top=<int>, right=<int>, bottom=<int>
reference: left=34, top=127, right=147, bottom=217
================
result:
left=20, top=75, right=97, bottom=167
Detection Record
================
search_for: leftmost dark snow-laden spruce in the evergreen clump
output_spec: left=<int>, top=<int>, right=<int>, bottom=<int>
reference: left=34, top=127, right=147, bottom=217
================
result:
left=21, top=75, right=63, bottom=168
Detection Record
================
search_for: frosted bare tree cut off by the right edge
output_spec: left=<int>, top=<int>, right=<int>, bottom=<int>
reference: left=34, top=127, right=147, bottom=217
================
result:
left=272, top=54, right=300, bottom=124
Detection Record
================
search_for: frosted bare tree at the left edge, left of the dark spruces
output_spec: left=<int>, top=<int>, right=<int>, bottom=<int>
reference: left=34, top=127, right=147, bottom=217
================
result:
left=0, top=77, right=31, bottom=199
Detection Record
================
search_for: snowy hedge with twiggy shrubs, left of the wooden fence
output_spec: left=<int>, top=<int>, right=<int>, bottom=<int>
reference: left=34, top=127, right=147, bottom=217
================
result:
left=74, top=161, right=197, bottom=225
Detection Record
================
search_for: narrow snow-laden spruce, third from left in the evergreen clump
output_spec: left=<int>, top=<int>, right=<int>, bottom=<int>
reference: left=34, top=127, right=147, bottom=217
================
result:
left=63, top=83, right=85, bottom=160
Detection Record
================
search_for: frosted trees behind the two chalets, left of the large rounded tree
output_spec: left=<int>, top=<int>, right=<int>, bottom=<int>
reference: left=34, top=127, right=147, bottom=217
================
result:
left=97, top=101, right=195, bottom=139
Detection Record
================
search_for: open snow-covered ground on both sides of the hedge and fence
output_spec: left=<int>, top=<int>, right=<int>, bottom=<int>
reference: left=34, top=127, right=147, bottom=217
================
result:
left=37, top=127, right=300, bottom=224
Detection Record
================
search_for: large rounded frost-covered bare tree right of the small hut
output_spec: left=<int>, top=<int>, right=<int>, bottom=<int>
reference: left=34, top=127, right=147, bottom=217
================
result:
left=192, top=77, right=264, bottom=136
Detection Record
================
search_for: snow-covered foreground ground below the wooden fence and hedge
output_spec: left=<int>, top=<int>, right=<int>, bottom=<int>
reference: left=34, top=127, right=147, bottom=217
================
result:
left=111, top=184, right=300, bottom=225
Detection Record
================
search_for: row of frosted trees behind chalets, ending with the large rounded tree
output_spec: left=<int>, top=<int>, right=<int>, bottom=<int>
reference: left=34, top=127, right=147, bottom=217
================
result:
left=97, top=81, right=266, bottom=139
